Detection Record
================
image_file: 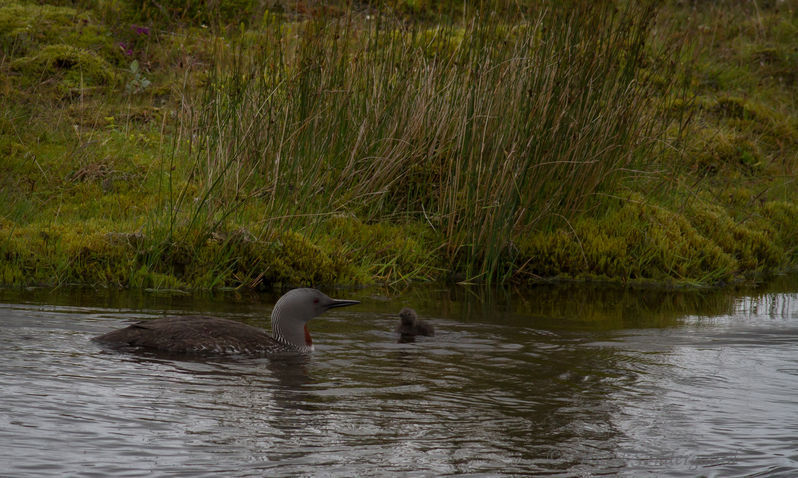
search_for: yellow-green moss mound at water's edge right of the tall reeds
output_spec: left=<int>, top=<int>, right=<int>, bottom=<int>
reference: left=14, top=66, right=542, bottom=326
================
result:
left=519, top=198, right=735, bottom=283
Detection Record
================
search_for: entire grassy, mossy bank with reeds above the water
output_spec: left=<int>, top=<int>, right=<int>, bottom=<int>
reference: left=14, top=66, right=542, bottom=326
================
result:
left=0, top=0, right=798, bottom=290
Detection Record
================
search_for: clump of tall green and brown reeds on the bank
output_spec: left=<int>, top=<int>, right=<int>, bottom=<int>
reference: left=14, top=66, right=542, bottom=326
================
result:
left=173, top=2, right=664, bottom=281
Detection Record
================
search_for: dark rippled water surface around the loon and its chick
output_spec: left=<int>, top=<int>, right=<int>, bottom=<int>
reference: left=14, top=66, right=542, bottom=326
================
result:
left=0, top=277, right=798, bottom=477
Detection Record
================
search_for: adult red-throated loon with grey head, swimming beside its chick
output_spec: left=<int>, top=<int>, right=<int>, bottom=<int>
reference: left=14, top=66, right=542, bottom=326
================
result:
left=93, top=289, right=360, bottom=356
